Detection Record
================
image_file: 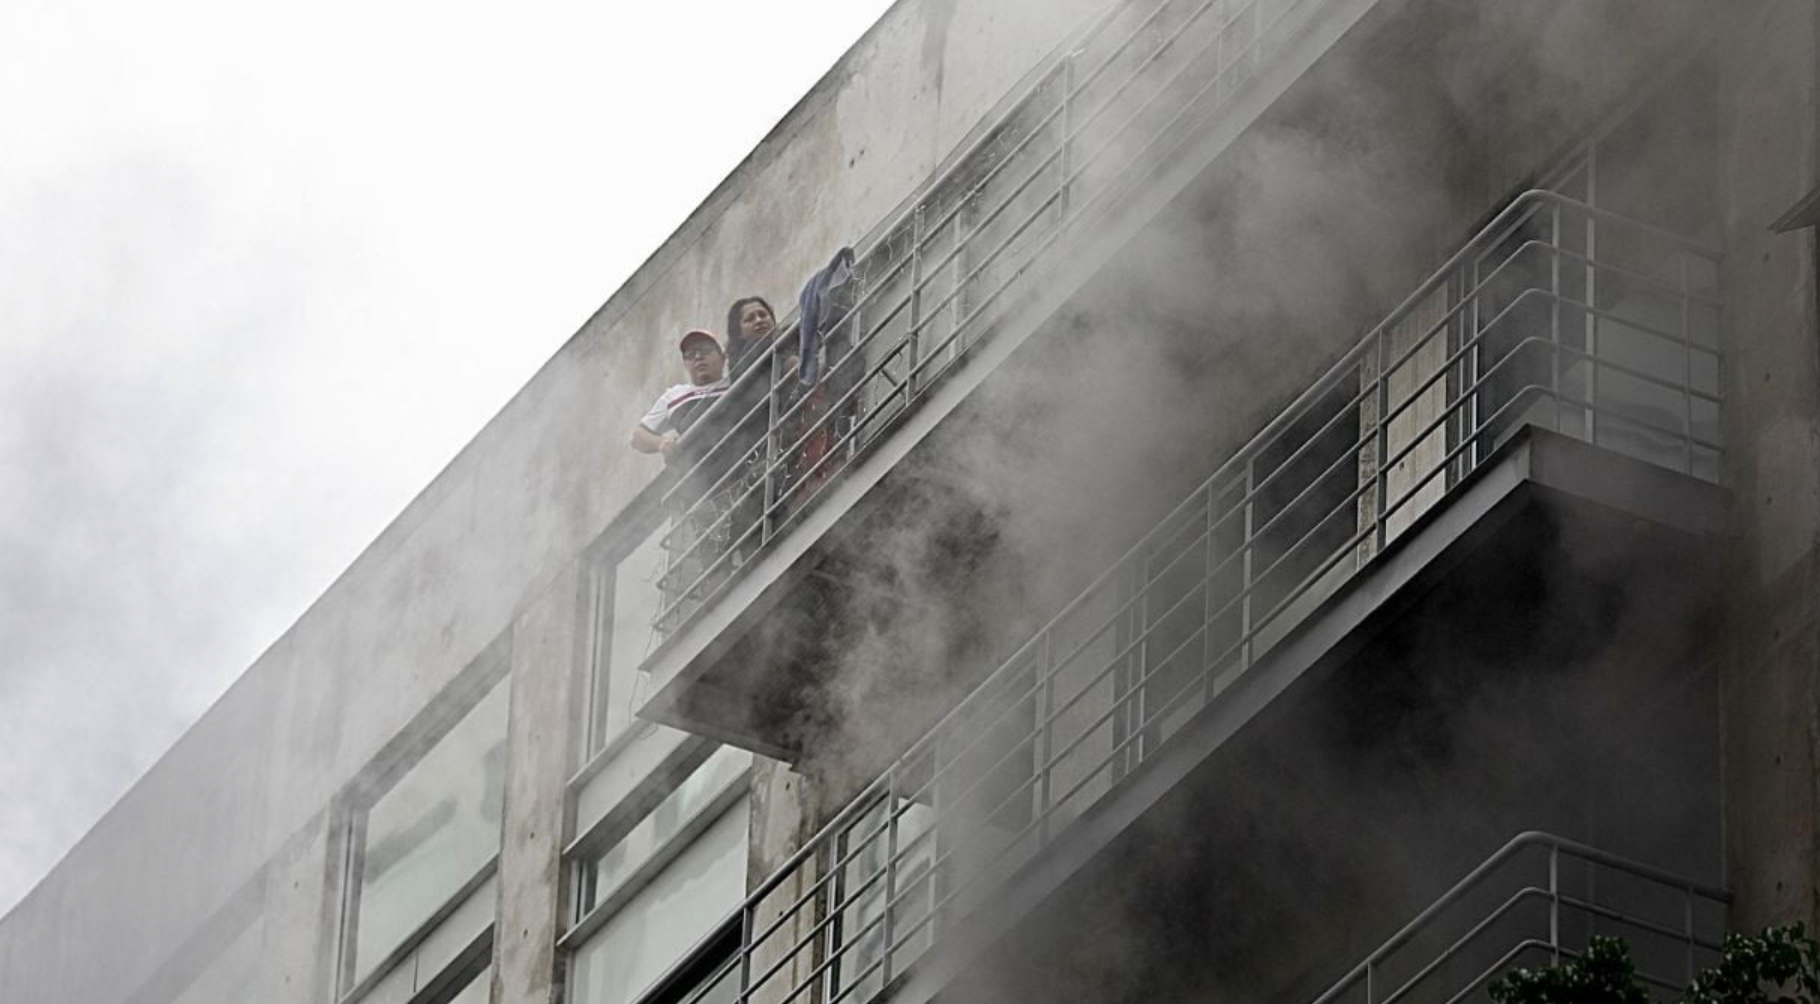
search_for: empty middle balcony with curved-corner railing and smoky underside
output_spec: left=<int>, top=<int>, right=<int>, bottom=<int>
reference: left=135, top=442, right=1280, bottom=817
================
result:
left=618, top=191, right=1724, bottom=1004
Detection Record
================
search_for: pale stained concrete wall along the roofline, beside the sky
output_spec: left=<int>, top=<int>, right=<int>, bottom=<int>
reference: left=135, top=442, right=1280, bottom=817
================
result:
left=0, top=0, right=1103, bottom=1002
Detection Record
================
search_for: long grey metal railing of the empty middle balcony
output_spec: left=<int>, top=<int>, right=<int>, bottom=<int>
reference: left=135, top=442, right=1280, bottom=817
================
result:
left=651, top=191, right=1720, bottom=1004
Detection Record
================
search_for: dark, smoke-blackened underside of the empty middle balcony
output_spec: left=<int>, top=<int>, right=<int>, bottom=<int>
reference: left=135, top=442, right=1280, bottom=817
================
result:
left=892, top=427, right=1725, bottom=1004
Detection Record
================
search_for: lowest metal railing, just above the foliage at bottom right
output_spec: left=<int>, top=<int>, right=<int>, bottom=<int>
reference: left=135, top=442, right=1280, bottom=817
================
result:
left=1314, top=833, right=1731, bottom=1004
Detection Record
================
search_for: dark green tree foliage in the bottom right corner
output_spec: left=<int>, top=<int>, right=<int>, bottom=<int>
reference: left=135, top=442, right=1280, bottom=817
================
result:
left=1487, top=924, right=1820, bottom=1004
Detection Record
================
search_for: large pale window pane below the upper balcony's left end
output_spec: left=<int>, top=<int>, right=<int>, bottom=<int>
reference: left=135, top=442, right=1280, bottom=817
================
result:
left=571, top=798, right=746, bottom=1004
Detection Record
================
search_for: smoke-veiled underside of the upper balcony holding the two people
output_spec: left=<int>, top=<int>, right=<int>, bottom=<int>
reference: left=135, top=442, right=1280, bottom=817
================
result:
left=639, top=0, right=1718, bottom=760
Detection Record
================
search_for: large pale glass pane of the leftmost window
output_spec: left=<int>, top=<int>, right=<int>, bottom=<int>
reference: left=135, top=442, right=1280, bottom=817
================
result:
left=353, top=680, right=506, bottom=980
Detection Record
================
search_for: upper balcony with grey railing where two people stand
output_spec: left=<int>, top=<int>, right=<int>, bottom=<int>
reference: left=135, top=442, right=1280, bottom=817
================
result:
left=617, top=0, right=1412, bottom=758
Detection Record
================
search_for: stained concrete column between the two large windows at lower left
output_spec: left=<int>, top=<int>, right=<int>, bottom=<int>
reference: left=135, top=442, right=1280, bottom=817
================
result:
left=491, top=571, right=581, bottom=1004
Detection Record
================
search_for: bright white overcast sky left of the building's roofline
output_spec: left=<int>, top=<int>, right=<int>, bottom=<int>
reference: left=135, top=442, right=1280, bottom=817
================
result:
left=0, top=0, right=890, bottom=913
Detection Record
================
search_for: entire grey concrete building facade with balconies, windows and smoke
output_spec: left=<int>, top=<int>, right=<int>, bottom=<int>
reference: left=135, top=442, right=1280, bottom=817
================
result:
left=0, top=0, right=1820, bottom=1004
